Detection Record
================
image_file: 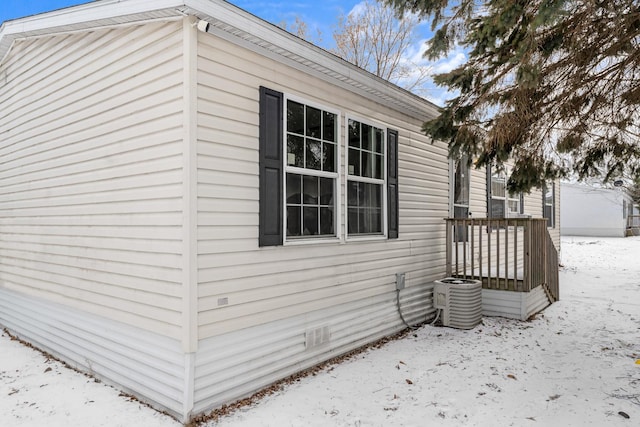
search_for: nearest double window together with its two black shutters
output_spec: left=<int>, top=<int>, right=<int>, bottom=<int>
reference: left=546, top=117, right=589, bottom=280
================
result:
left=259, top=87, right=399, bottom=246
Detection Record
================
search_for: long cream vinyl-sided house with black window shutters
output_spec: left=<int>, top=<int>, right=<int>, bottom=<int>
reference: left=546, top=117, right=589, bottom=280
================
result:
left=0, top=0, right=559, bottom=421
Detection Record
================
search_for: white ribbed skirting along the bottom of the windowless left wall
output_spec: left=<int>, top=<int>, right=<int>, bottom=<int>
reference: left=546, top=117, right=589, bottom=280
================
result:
left=0, top=288, right=185, bottom=417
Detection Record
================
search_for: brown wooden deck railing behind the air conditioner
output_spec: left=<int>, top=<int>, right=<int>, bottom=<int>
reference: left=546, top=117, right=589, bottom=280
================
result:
left=446, top=218, right=560, bottom=301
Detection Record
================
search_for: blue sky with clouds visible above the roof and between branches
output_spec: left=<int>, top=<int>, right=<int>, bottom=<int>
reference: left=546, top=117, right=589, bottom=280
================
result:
left=0, top=0, right=465, bottom=105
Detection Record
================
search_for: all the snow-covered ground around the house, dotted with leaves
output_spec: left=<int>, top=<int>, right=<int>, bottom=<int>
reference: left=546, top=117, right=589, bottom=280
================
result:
left=0, top=237, right=640, bottom=427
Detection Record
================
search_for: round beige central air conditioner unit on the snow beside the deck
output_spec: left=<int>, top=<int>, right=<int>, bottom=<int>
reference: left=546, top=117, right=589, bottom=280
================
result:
left=433, top=277, right=482, bottom=329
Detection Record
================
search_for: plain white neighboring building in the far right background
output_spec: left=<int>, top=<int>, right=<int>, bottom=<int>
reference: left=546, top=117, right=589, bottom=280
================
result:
left=560, top=182, right=637, bottom=237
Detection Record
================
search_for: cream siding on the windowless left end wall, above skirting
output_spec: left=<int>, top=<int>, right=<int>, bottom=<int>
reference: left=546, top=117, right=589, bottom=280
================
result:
left=0, top=23, right=183, bottom=337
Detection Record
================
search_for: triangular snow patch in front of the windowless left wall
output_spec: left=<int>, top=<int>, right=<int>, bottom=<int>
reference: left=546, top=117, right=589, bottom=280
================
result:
left=0, top=333, right=180, bottom=427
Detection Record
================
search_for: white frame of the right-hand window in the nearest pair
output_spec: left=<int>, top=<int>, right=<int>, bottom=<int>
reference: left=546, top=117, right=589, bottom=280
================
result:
left=343, top=114, right=389, bottom=241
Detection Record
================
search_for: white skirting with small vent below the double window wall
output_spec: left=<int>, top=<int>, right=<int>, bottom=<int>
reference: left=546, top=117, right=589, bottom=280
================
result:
left=194, top=286, right=433, bottom=413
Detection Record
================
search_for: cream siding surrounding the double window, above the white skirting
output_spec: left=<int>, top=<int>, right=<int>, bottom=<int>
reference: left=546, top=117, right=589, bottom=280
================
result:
left=198, top=35, right=448, bottom=339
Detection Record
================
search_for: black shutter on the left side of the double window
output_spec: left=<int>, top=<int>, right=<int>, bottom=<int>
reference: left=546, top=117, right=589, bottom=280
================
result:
left=258, top=86, right=283, bottom=246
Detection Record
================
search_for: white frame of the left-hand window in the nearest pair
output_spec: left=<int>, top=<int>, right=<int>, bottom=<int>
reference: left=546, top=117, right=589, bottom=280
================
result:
left=282, top=93, right=343, bottom=245
